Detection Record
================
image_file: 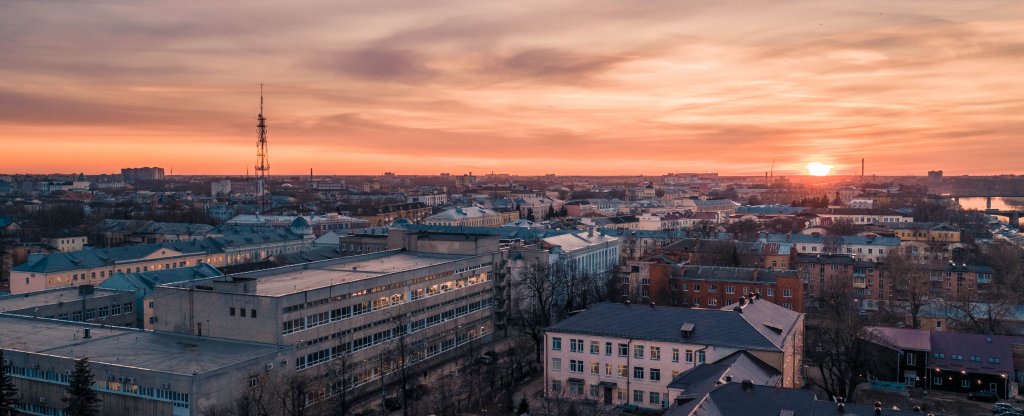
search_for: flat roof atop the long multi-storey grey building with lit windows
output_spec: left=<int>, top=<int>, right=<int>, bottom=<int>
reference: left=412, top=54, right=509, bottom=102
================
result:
left=233, top=252, right=473, bottom=296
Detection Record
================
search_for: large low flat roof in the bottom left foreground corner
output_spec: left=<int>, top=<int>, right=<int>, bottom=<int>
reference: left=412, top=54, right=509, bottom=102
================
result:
left=0, top=314, right=287, bottom=375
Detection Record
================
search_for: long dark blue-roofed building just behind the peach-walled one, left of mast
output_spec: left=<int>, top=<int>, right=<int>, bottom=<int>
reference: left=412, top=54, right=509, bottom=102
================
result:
left=89, top=219, right=213, bottom=247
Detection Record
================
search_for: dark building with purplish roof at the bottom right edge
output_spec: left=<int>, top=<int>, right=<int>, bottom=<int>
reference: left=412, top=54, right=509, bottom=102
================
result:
left=865, top=327, right=1024, bottom=399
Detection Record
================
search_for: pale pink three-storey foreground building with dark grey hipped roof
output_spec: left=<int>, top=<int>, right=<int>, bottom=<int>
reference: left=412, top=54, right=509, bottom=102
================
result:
left=544, top=300, right=804, bottom=409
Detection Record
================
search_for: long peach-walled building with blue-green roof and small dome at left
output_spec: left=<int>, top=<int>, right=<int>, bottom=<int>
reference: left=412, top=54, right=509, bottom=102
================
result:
left=10, top=222, right=313, bottom=293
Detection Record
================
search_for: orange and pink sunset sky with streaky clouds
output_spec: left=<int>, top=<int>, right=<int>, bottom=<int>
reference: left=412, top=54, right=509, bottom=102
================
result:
left=0, top=0, right=1024, bottom=175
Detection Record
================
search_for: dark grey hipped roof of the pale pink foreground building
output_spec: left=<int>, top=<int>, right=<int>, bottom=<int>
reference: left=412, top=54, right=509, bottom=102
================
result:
left=549, top=300, right=802, bottom=351
